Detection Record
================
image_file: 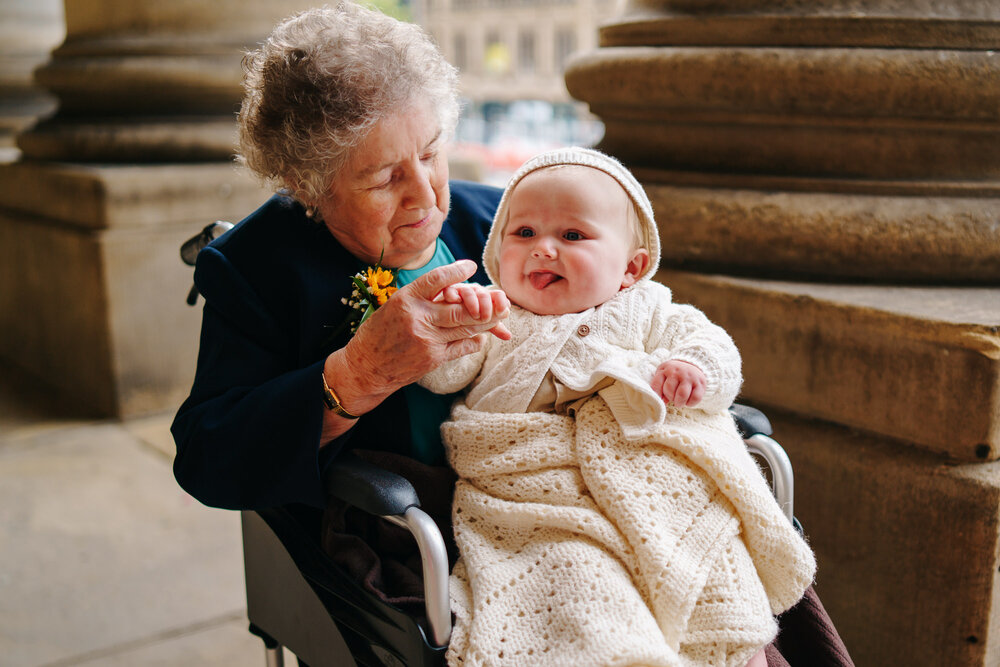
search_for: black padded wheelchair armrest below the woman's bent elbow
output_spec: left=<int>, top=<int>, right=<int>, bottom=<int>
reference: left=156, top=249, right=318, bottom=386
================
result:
left=323, top=451, right=420, bottom=516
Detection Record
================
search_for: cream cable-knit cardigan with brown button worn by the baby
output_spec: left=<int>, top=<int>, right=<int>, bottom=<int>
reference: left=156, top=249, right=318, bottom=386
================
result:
left=420, top=279, right=742, bottom=428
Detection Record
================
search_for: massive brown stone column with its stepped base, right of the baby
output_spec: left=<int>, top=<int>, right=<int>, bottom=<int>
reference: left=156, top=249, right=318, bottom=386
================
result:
left=566, top=0, right=1000, bottom=665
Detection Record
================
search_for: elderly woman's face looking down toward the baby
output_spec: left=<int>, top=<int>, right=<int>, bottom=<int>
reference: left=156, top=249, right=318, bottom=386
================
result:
left=318, top=102, right=449, bottom=269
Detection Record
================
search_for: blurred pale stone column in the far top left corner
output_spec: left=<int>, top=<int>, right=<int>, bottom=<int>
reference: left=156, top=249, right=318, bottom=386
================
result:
left=0, top=0, right=65, bottom=162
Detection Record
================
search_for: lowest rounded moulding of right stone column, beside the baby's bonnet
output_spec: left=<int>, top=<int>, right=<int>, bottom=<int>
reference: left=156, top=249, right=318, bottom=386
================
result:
left=637, top=177, right=1000, bottom=285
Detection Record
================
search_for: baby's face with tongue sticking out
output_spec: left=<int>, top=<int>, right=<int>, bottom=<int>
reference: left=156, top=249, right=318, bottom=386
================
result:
left=499, top=166, right=649, bottom=315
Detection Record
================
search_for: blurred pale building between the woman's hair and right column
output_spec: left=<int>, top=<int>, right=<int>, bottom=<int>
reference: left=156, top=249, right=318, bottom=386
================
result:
left=410, top=0, right=615, bottom=185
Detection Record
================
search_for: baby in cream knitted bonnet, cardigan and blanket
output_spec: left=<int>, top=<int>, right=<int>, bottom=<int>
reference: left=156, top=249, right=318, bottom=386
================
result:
left=421, top=148, right=815, bottom=667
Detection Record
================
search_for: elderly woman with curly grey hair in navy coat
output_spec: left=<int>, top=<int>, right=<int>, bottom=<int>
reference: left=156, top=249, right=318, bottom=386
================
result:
left=171, top=2, right=509, bottom=509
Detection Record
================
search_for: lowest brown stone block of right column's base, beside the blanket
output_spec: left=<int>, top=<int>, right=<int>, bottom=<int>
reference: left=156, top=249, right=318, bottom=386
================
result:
left=762, top=406, right=1000, bottom=665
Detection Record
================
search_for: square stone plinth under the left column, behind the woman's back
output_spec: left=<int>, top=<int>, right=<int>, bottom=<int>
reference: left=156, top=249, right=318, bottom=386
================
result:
left=0, top=162, right=266, bottom=417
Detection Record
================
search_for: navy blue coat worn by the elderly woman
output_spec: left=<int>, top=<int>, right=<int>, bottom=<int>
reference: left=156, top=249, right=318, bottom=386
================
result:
left=171, top=181, right=501, bottom=509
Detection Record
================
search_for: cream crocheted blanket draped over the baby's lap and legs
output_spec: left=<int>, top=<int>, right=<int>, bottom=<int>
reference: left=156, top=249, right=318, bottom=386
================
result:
left=442, top=397, right=815, bottom=667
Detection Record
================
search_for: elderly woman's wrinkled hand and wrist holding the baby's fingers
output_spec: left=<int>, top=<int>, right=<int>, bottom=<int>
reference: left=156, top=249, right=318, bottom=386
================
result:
left=324, top=260, right=510, bottom=442
